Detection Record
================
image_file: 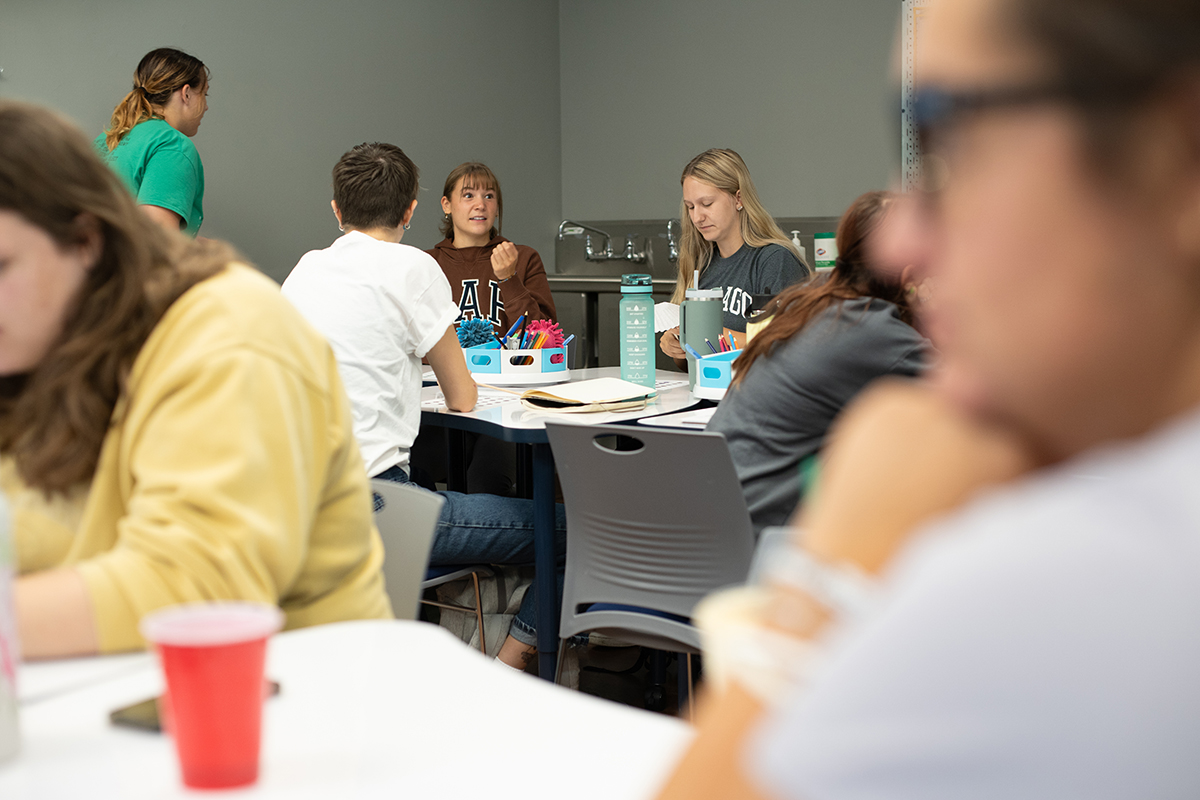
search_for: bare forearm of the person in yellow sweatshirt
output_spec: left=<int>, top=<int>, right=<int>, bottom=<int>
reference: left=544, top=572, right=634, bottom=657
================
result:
left=14, top=569, right=100, bottom=658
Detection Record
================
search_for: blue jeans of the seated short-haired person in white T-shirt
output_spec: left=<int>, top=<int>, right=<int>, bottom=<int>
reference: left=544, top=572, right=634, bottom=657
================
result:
left=376, top=467, right=566, bottom=645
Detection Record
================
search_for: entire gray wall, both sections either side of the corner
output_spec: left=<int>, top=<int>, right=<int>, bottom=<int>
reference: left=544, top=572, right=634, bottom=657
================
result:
left=0, top=0, right=900, bottom=279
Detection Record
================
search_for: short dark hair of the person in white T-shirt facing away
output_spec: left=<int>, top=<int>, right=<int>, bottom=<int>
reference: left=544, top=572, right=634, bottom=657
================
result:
left=334, top=142, right=420, bottom=229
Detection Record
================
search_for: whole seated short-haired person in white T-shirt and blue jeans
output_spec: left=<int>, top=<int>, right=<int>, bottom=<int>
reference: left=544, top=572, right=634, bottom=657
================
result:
left=282, top=143, right=566, bottom=668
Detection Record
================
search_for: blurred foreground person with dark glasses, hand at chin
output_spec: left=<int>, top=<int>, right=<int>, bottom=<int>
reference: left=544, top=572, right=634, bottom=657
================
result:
left=662, top=0, right=1200, bottom=800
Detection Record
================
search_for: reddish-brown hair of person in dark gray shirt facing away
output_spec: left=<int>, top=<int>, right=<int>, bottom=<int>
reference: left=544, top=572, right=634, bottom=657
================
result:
left=732, top=192, right=913, bottom=385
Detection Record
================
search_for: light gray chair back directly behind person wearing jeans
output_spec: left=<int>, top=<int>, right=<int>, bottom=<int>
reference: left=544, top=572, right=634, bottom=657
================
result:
left=371, top=479, right=445, bottom=619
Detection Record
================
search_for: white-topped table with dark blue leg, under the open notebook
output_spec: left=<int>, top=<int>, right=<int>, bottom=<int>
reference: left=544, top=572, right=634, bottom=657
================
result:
left=421, top=367, right=698, bottom=680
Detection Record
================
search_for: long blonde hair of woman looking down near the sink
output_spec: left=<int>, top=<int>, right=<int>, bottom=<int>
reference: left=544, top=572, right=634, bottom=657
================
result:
left=671, top=148, right=804, bottom=302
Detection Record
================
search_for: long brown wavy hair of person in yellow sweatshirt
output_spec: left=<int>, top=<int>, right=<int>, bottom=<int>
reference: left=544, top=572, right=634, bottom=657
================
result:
left=0, top=101, right=228, bottom=494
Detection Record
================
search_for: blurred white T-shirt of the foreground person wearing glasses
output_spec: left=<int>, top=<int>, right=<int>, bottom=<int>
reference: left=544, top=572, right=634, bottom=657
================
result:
left=746, top=415, right=1200, bottom=800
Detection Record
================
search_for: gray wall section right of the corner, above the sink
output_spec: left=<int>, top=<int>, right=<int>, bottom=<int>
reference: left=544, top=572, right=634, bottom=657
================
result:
left=559, top=0, right=900, bottom=219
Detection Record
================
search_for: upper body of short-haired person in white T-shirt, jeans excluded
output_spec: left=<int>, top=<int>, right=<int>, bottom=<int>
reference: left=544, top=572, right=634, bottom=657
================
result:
left=283, top=143, right=476, bottom=477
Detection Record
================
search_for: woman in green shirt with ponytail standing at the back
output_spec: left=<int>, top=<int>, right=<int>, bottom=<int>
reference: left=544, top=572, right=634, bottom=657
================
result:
left=96, top=47, right=209, bottom=236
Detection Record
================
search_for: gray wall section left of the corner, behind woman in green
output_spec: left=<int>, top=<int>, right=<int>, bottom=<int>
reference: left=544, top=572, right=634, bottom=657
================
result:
left=0, top=0, right=562, bottom=281
